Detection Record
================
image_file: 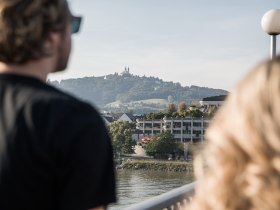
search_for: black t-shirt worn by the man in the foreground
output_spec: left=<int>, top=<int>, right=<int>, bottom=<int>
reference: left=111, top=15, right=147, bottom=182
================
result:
left=0, top=74, right=116, bottom=210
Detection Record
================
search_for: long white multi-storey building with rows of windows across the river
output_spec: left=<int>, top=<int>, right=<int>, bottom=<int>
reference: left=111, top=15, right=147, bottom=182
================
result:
left=136, top=117, right=211, bottom=142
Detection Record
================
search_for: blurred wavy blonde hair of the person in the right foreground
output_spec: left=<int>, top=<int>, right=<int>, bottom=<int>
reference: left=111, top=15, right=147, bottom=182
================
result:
left=188, top=58, right=280, bottom=210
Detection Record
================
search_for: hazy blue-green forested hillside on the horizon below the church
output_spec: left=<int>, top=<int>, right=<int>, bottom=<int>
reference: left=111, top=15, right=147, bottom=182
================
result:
left=51, top=72, right=227, bottom=107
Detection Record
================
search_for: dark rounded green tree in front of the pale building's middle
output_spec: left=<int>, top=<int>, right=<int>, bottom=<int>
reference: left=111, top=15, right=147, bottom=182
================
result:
left=145, top=132, right=178, bottom=158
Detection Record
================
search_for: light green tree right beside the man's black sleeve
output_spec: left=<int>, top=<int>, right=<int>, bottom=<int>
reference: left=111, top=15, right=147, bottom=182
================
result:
left=109, top=121, right=135, bottom=154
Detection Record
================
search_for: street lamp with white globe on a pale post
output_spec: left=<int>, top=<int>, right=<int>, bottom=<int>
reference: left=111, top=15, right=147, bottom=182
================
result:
left=261, top=9, right=280, bottom=59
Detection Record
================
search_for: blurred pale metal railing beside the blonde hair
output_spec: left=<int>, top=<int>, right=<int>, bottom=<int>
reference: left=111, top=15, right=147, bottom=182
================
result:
left=124, top=182, right=195, bottom=210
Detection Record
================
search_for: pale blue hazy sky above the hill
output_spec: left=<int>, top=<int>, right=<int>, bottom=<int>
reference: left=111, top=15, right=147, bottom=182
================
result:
left=49, top=0, right=280, bottom=91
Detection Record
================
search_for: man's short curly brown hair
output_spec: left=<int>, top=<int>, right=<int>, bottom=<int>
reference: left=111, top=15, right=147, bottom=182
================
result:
left=0, top=0, right=70, bottom=64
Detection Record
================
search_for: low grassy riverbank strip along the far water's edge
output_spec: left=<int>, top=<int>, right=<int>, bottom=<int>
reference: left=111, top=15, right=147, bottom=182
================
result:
left=117, top=160, right=193, bottom=172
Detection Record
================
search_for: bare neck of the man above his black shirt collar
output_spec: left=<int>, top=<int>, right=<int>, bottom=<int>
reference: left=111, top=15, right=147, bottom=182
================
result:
left=0, top=58, right=54, bottom=81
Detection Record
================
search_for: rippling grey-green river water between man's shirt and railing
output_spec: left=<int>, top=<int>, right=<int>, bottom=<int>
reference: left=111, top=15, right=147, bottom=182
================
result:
left=108, top=170, right=193, bottom=210
